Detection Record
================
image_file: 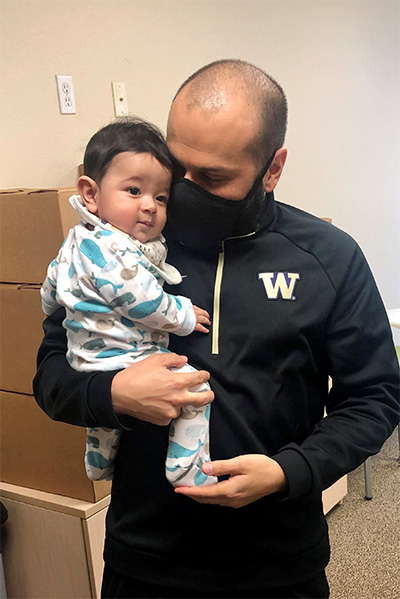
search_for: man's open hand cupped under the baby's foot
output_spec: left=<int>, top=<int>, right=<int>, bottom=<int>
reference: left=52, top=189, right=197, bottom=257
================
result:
left=175, top=454, right=287, bottom=508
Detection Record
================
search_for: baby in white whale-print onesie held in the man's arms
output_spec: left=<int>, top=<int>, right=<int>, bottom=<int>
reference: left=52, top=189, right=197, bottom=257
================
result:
left=41, top=118, right=217, bottom=486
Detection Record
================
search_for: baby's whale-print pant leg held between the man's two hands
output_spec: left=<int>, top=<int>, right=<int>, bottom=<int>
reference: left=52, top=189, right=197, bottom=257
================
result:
left=165, top=364, right=218, bottom=487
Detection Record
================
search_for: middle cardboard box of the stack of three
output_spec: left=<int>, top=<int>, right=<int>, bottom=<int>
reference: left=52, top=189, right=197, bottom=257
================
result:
left=0, top=283, right=45, bottom=394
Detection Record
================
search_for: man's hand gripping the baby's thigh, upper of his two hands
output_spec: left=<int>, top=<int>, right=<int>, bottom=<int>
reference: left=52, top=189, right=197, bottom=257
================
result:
left=111, top=353, right=214, bottom=426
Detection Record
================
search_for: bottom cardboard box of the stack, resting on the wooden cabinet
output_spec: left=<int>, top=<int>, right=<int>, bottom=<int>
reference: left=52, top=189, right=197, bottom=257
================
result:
left=0, top=391, right=111, bottom=502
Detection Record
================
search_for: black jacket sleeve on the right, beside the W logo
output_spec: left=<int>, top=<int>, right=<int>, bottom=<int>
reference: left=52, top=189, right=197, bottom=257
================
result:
left=274, top=238, right=400, bottom=497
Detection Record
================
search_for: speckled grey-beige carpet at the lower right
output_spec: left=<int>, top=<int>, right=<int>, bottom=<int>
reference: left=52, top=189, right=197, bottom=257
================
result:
left=327, top=429, right=400, bottom=599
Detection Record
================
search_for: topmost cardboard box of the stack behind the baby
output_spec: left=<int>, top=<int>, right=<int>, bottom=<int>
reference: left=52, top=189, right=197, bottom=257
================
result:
left=0, top=187, right=79, bottom=283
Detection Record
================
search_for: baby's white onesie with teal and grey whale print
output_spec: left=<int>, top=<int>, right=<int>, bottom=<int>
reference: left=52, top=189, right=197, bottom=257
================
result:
left=41, top=195, right=217, bottom=486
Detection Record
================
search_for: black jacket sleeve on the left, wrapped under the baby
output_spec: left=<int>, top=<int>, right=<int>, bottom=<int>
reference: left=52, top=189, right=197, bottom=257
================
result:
left=33, top=308, right=126, bottom=428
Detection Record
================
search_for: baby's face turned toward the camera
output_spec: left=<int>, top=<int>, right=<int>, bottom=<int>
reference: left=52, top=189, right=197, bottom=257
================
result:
left=96, top=152, right=172, bottom=243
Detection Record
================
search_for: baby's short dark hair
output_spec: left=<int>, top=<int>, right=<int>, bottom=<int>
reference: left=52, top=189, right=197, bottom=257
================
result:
left=83, top=117, right=173, bottom=185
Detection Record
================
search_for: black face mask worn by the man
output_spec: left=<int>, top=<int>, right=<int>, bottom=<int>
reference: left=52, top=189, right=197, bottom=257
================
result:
left=166, top=152, right=275, bottom=251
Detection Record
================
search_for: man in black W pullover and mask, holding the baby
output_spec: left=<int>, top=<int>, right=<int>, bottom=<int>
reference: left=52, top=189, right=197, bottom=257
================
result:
left=35, top=60, right=399, bottom=598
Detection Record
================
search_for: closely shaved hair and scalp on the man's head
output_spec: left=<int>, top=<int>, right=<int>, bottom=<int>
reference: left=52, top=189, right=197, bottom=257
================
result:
left=174, top=59, right=287, bottom=167
